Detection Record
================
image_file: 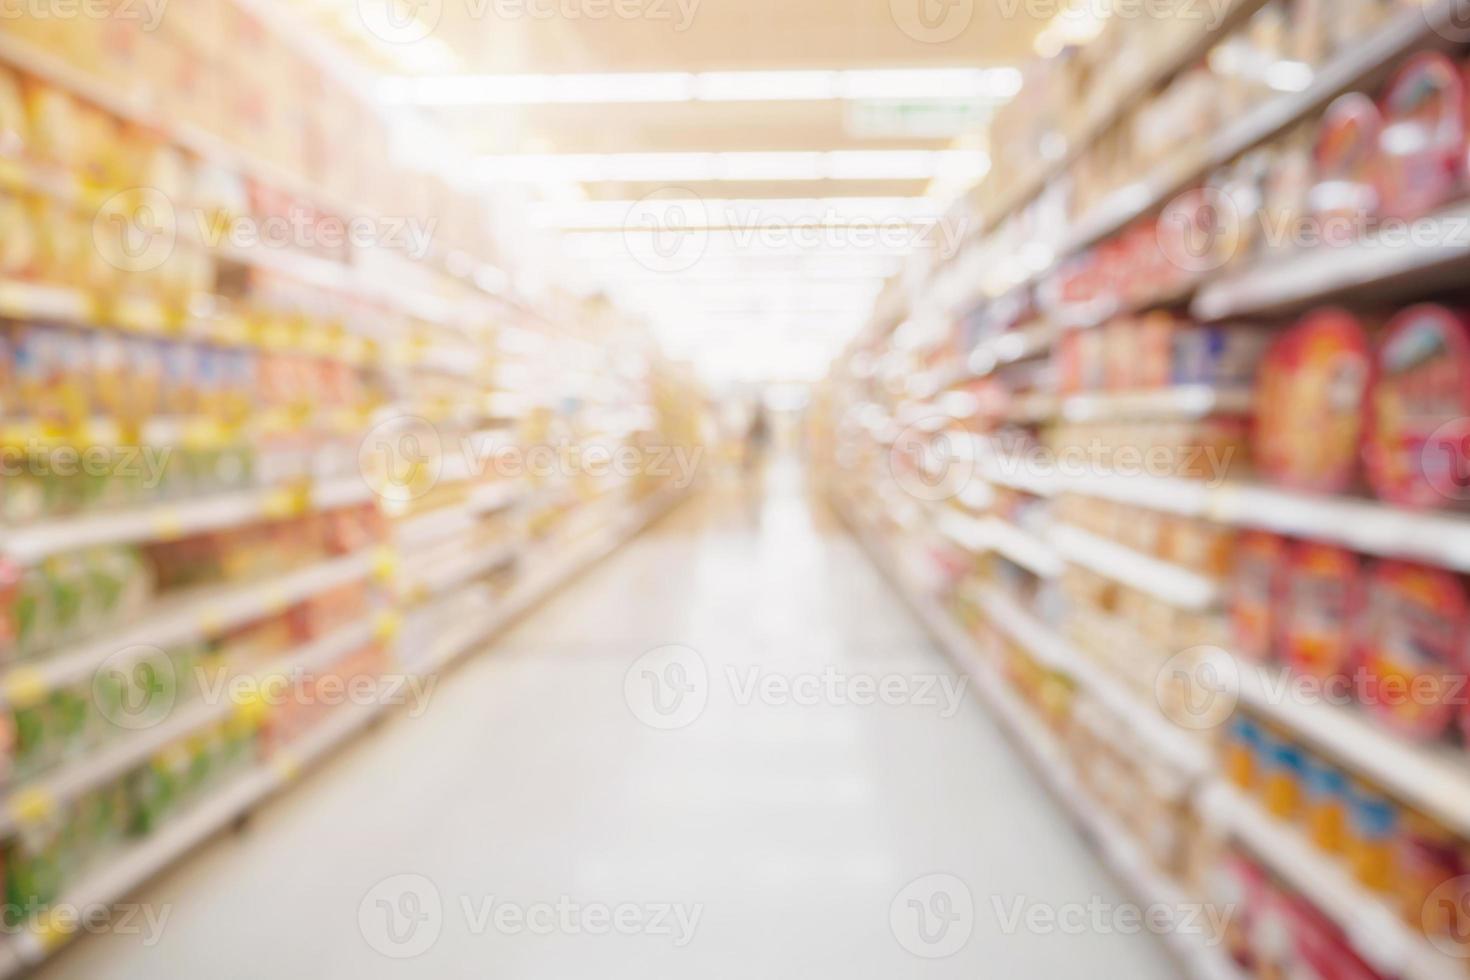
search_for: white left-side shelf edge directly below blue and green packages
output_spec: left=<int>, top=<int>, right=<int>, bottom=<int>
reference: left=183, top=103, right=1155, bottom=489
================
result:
left=3, top=478, right=373, bottom=564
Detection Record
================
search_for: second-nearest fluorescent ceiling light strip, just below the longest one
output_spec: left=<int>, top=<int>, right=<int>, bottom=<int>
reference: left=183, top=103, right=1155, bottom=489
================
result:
left=479, top=150, right=991, bottom=184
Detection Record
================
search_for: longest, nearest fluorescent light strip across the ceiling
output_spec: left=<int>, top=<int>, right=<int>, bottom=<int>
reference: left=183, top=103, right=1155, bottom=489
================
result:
left=381, top=68, right=1022, bottom=106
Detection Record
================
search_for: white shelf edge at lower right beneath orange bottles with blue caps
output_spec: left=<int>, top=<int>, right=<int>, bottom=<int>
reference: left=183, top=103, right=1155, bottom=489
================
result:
left=1200, top=783, right=1466, bottom=980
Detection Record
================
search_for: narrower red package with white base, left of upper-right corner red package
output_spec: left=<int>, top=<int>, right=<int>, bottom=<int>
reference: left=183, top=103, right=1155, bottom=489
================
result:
left=1308, top=93, right=1383, bottom=235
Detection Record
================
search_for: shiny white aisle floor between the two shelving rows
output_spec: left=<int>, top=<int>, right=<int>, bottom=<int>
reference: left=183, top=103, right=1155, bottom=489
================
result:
left=43, top=472, right=1175, bottom=980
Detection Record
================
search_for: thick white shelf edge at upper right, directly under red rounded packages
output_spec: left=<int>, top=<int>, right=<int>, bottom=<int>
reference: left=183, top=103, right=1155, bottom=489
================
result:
left=1194, top=204, right=1470, bottom=320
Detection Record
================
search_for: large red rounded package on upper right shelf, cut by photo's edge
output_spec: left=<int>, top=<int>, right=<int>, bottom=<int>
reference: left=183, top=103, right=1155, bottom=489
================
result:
left=1380, top=51, right=1466, bottom=217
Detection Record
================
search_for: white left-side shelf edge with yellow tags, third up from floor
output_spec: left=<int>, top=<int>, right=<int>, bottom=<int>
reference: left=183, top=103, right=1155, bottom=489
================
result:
left=0, top=550, right=388, bottom=704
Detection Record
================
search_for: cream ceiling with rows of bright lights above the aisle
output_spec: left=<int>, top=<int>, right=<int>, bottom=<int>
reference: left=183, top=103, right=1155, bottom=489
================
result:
left=304, top=0, right=1051, bottom=382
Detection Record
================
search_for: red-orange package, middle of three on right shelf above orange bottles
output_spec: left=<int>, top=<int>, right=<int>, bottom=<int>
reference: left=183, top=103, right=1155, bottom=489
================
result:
left=1280, top=541, right=1363, bottom=680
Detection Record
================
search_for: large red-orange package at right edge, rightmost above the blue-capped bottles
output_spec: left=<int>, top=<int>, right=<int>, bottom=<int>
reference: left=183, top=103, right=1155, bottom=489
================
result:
left=1358, top=561, right=1470, bottom=741
